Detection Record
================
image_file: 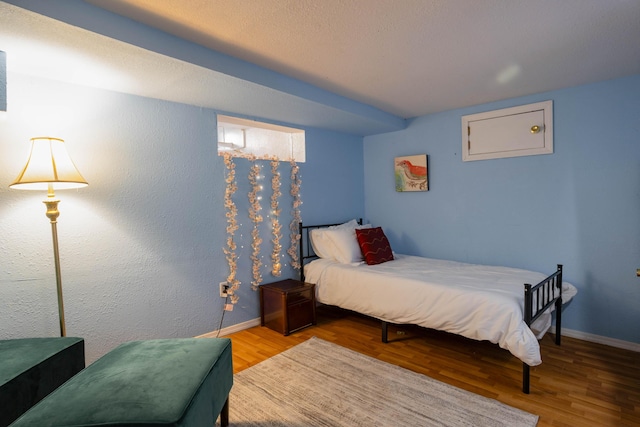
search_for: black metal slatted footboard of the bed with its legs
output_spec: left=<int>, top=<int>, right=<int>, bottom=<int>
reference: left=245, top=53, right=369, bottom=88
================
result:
left=522, top=264, right=562, bottom=394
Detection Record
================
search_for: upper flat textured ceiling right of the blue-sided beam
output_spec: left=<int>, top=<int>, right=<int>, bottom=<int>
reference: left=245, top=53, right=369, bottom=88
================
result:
left=88, top=0, right=640, bottom=118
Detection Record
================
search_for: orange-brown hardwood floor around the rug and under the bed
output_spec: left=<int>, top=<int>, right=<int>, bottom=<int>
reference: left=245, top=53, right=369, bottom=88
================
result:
left=228, top=306, right=640, bottom=427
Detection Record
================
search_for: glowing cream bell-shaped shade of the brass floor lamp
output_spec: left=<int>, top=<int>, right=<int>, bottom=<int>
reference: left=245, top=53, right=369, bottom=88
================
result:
left=9, top=137, right=88, bottom=190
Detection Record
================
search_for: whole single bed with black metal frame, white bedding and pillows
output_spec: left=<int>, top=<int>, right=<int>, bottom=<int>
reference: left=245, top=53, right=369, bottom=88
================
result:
left=299, top=220, right=577, bottom=393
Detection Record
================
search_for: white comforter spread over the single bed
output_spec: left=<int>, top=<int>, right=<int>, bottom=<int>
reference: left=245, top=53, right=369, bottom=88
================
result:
left=304, top=254, right=577, bottom=366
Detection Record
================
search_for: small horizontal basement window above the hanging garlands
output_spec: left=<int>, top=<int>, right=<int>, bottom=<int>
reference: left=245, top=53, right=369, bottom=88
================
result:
left=218, top=115, right=305, bottom=162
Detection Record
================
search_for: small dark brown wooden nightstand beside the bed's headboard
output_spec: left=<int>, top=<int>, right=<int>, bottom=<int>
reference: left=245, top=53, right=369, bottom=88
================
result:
left=260, top=279, right=316, bottom=335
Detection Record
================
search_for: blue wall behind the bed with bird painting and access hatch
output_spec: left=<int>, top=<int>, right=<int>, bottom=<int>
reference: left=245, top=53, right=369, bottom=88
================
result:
left=364, top=76, right=640, bottom=343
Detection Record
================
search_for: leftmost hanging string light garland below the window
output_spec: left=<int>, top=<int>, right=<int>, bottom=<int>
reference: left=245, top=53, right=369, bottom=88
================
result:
left=223, top=153, right=240, bottom=304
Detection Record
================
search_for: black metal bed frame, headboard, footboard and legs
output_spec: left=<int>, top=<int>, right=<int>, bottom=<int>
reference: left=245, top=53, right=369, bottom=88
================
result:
left=299, top=219, right=562, bottom=394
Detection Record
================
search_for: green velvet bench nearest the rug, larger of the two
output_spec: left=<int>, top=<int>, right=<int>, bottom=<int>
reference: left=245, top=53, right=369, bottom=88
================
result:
left=12, top=338, right=233, bottom=427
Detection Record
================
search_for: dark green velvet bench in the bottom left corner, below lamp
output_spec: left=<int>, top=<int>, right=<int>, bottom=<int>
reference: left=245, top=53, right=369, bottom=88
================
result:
left=0, top=337, right=84, bottom=427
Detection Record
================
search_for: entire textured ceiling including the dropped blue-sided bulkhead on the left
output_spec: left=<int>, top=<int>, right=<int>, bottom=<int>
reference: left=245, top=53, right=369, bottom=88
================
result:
left=0, top=0, right=640, bottom=135
